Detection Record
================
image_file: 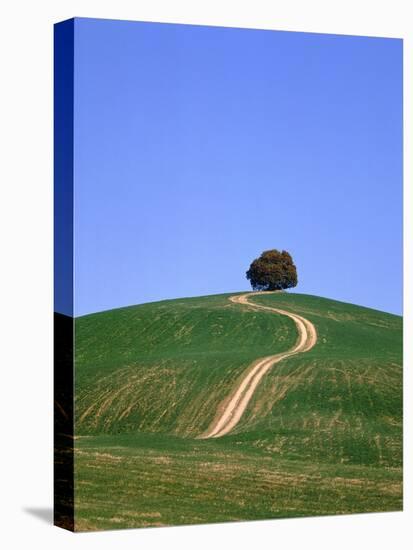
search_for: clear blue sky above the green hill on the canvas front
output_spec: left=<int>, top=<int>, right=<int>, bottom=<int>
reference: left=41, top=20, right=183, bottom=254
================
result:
left=74, top=19, right=402, bottom=315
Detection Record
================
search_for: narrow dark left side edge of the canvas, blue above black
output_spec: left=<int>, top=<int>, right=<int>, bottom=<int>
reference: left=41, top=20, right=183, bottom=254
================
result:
left=54, top=20, right=74, bottom=531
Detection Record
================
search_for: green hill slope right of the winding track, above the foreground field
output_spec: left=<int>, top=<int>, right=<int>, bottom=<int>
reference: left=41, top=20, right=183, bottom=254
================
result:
left=225, top=294, right=402, bottom=466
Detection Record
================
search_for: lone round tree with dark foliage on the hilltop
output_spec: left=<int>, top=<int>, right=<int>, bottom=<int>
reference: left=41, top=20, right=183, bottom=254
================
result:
left=247, top=250, right=297, bottom=290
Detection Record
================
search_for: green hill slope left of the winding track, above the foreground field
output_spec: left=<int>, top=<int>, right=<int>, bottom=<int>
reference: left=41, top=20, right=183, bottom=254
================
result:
left=76, top=295, right=296, bottom=436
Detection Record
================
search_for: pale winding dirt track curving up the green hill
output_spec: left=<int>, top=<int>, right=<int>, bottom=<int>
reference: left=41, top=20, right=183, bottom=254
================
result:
left=200, top=292, right=317, bottom=439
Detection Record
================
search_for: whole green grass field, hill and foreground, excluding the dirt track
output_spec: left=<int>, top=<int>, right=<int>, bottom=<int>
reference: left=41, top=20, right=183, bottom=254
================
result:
left=75, top=293, right=402, bottom=530
